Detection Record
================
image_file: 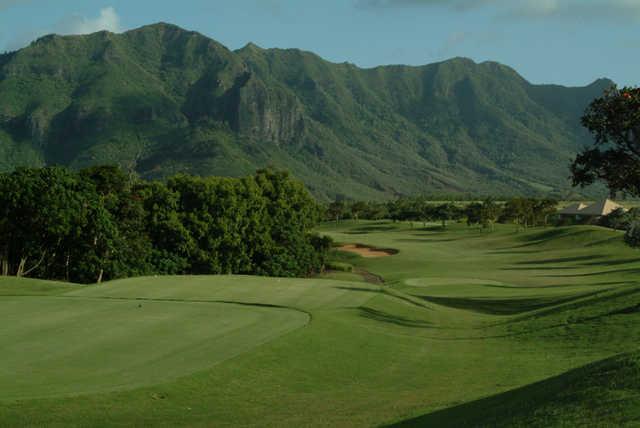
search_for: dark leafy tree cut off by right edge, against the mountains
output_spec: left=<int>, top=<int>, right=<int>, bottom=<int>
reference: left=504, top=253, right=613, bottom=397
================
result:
left=571, top=86, right=640, bottom=196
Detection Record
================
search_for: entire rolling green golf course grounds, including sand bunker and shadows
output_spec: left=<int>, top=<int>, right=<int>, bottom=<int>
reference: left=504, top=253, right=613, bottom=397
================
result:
left=0, top=221, right=640, bottom=427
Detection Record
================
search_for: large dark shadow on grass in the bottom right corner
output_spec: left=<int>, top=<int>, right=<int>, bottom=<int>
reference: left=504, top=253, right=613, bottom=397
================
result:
left=387, top=353, right=640, bottom=427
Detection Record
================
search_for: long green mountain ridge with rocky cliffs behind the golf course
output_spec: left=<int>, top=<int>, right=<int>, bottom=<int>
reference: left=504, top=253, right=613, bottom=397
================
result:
left=0, top=24, right=612, bottom=199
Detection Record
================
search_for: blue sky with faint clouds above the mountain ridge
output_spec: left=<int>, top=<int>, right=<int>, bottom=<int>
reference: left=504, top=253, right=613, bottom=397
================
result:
left=0, top=0, right=640, bottom=86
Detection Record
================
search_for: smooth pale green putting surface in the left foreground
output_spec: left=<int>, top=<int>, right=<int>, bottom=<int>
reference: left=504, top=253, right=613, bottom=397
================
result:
left=0, top=296, right=308, bottom=399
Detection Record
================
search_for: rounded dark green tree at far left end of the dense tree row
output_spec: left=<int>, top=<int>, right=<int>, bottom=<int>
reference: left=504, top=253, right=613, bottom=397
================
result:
left=0, top=167, right=118, bottom=282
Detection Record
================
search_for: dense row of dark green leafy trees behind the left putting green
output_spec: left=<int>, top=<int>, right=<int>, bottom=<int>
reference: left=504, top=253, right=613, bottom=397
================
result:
left=0, top=166, right=331, bottom=283
